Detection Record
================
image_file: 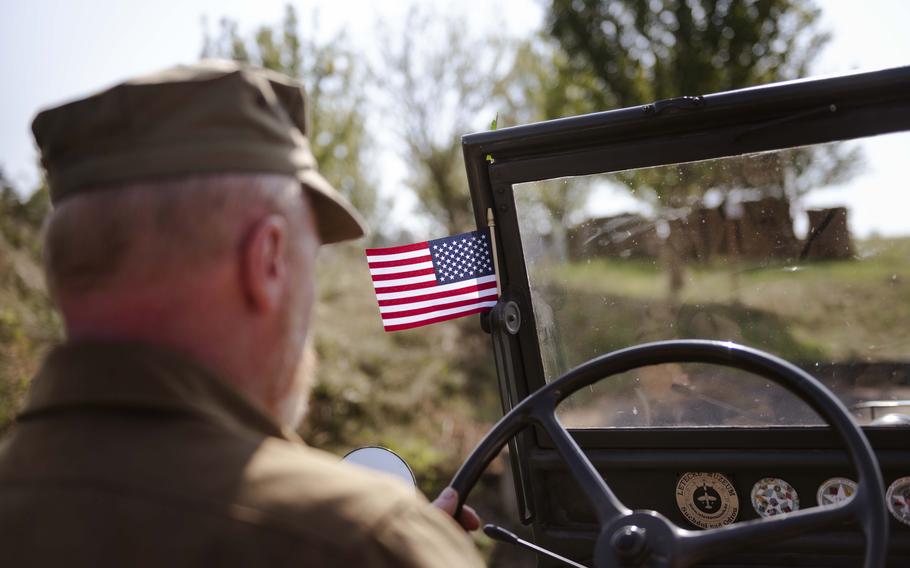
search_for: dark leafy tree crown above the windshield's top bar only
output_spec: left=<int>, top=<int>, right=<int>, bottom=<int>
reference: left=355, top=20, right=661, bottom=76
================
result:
left=547, top=0, right=830, bottom=108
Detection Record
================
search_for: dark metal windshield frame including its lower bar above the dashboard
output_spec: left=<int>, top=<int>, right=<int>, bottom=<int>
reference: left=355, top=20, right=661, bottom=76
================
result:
left=462, top=66, right=910, bottom=523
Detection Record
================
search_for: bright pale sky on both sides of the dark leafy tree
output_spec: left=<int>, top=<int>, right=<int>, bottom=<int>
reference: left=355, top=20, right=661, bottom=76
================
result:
left=0, top=0, right=910, bottom=232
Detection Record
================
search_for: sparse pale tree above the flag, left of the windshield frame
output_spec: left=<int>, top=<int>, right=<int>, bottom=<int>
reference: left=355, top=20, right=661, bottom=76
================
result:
left=374, top=7, right=510, bottom=233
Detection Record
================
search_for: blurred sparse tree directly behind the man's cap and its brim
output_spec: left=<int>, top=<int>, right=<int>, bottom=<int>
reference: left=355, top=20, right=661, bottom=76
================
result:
left=202, top=5, right=381, bottom=226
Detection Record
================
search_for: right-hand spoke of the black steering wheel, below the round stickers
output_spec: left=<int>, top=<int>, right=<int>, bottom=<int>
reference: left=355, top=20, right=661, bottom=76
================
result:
left=675, top=499, right=859, bottom=566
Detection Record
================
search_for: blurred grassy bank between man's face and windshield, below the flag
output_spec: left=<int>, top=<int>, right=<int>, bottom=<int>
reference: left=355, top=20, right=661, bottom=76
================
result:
left=305, top=245, right=499, bottom=491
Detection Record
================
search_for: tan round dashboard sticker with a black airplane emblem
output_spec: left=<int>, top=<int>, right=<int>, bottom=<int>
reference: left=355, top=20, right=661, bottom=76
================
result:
left=676, top=471, right=739, bottom=529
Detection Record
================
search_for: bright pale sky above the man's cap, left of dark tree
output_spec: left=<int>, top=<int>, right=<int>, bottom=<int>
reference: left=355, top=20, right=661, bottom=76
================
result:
left=0, top=0, right=543, bottom=189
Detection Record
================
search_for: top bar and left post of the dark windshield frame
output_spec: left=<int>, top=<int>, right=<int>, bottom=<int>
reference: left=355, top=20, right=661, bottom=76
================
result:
left=463, top=66, right=910, bottom=411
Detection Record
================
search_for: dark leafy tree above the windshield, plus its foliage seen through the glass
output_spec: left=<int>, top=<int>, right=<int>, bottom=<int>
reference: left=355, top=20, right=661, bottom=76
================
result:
left=546, top=0, right=861, bottom=229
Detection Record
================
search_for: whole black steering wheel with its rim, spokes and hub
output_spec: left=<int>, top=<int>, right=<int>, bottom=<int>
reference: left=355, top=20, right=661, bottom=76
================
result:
left=450, top=340, right=888, bottom=568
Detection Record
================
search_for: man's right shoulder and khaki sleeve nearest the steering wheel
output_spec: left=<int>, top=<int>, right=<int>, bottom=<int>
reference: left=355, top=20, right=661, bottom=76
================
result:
left=237, top=439, right=477, bottom=566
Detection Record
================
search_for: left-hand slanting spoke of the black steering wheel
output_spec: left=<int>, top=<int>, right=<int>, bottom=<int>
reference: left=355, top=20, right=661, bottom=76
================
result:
left=535, top=410, right=632, bottom=525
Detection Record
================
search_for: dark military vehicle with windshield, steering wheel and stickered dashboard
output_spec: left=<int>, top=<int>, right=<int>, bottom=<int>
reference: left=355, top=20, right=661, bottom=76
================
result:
left=452, top=67, right=910, bottom=567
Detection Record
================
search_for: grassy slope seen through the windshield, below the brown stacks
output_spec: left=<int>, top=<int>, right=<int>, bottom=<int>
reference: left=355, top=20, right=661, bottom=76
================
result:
left=531, top=234, right=910, bottom=370
